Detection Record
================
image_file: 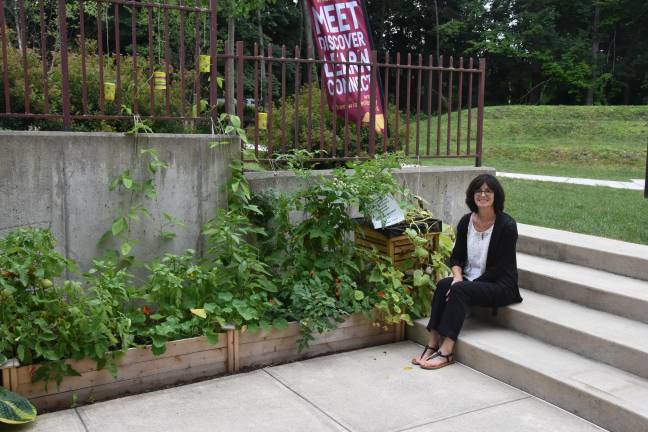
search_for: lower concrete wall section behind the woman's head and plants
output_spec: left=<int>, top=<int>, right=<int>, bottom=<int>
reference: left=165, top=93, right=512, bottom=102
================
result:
left=246, top=167, right=495, bottom=225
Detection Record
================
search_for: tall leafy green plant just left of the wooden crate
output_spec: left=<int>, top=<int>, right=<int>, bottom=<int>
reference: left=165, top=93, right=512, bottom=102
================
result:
left=254, top=151, right=412, bottom=349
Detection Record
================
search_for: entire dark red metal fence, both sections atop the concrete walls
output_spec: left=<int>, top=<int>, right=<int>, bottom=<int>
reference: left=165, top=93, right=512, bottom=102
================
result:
left=0, top=0, right=485, bottom=166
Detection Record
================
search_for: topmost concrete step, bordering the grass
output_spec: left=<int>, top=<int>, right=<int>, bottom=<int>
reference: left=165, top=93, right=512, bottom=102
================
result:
left=517, top=224, right=648, bottom=280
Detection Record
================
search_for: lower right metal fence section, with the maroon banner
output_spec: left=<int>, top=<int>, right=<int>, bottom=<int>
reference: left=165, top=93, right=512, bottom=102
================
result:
left=233, top=42, right=486, bottom=166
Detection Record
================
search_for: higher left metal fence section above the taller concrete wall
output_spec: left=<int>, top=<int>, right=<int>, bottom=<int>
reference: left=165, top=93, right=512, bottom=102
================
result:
left=0, top=0, right=218, bottom=125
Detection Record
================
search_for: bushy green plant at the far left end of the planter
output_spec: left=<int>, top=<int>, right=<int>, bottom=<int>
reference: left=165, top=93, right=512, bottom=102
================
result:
left=0, top=228, right=131, bottom=383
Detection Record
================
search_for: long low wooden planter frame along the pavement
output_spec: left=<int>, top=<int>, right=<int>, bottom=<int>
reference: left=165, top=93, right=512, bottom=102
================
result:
left=0, top=314, right=404, bottom=411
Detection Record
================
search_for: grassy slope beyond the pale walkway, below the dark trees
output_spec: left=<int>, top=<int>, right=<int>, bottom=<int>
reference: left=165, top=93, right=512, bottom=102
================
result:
left=410, top=106, right=648, bottom=180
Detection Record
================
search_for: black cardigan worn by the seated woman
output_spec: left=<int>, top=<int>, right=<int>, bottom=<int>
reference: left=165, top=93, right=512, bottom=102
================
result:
left=448, top=212, right=522, bottom=306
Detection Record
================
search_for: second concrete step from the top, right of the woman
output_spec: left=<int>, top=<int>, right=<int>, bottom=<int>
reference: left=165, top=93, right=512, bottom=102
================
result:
left=517, top=253, right=648, bottom=323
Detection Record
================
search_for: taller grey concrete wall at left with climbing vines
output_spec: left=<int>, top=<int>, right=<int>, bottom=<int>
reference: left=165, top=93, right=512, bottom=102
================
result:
left=0, top=131, right=240, bottom=270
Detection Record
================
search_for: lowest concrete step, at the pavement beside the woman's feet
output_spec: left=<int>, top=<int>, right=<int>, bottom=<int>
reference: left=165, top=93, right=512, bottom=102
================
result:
left=408, top=318, right=648, bottom=432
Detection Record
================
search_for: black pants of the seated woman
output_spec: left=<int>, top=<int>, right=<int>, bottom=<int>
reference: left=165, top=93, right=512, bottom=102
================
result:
left=427, top=277, right=509, bottom=341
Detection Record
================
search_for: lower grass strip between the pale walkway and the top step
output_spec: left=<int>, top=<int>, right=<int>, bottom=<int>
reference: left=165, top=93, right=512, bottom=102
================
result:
left=501, top=178, right=648, bottom=244
